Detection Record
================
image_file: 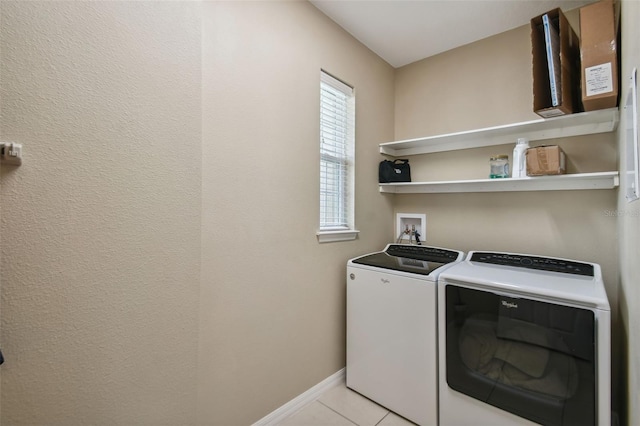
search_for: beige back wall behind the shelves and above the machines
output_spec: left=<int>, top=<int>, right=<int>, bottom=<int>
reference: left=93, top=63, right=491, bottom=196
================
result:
left=392, top=6, right=624, bottom=418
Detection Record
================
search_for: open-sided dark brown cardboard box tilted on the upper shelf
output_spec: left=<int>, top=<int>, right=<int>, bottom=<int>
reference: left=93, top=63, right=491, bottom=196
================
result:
left=531, top=8, right=582, bottom=118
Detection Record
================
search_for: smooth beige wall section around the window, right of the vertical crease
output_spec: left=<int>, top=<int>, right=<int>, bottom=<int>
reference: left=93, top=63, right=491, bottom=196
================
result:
left=199, top=2, right=393, bottom=424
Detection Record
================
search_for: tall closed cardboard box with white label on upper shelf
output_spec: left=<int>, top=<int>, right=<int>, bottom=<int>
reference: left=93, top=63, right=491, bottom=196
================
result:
left=580, top=0, right=619, bottom=111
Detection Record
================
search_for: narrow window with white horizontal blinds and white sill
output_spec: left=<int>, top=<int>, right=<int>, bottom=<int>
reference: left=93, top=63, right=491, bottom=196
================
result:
left=318, top=71, right=358, bottom=242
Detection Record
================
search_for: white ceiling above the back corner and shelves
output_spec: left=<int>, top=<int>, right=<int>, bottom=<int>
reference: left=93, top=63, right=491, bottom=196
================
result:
left=310, top=0, right=594, bottom=68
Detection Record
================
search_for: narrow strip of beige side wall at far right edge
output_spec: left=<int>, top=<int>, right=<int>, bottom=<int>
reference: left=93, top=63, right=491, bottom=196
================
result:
left=617, top=0, right=640, bottom=425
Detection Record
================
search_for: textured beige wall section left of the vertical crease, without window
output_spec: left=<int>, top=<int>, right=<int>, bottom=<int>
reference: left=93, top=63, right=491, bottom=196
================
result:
left=0, top=1, right=201, bottom=426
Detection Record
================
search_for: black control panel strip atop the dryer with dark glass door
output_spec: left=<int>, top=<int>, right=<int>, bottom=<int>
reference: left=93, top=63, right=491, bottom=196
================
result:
left=470, top=252, right=593, bottom=277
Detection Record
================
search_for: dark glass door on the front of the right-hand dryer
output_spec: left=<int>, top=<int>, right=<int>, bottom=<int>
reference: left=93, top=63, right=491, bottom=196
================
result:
left=445, top=285, right=596, bottom=425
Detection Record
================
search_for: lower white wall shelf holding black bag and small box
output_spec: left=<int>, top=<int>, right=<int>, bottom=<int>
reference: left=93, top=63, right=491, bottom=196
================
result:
left=380, top=172, right=620, bottom=194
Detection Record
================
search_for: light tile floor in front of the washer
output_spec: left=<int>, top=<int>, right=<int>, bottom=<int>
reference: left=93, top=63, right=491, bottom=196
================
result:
left=279, top=383, right=414, bottom=426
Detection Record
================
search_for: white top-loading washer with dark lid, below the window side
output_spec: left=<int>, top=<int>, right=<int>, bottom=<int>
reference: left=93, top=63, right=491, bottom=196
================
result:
left=346, top=244, right=464, bottom=425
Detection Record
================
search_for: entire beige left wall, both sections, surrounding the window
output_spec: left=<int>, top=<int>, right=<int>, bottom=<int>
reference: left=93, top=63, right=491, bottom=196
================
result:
left=0, top=1, right=393, bottom=425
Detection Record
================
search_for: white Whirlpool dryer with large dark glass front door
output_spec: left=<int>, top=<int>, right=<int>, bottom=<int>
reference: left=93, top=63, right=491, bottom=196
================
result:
left=438, top=251, right=611, bottom=426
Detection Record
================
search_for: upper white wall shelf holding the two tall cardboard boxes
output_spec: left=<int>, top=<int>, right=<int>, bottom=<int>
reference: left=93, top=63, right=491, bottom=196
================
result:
left=380, top=108, right=618, bottom=157
